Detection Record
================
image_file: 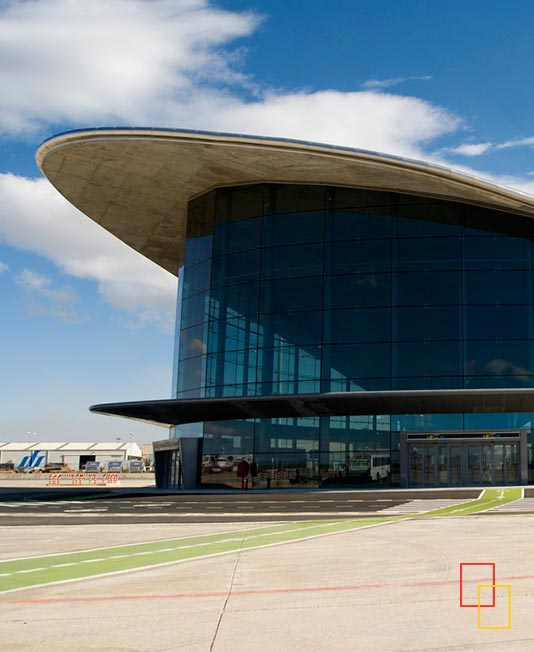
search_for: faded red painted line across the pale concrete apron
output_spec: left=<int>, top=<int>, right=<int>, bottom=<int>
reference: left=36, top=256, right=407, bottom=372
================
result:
left=5, top=575, right=534, bottom=604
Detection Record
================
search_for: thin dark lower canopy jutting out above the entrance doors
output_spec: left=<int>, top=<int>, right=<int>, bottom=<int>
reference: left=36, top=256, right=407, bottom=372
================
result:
left=91, top=389, right=534, bottom=426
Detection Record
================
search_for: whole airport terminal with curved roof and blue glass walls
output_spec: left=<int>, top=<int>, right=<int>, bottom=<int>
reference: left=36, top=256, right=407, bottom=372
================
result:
left=37, top=129, right=534, bottom=488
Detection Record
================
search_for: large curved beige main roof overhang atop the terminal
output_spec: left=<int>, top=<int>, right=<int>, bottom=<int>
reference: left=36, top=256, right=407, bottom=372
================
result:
left=37, top=128, right=534, bottom=275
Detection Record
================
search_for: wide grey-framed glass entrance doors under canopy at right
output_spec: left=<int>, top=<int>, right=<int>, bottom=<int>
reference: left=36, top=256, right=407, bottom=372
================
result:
left=400, top=431, right=528, bottom=487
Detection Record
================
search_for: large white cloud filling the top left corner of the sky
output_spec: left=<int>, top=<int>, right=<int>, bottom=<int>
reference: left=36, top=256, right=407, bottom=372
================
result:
left=0, top=0, right=260, bottom=133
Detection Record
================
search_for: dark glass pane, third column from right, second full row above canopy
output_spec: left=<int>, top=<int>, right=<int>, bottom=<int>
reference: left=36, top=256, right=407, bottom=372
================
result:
left=324, top=308, right=391, bottom=344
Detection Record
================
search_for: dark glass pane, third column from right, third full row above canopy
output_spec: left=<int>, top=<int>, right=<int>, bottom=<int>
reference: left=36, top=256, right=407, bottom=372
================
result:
left=325, top=274, right=391, bottom=308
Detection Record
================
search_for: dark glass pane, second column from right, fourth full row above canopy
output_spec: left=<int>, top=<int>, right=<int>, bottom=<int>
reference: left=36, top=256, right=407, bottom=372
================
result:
left=393, top=238, right=462, bottom=271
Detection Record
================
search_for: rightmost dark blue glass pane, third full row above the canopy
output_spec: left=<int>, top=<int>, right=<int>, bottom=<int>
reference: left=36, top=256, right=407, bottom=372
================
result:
left=464, top=271, right=532, bottom=304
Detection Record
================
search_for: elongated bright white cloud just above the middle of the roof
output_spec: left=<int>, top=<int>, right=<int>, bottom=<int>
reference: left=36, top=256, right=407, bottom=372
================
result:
left=195, top=90, right=462, bottom=157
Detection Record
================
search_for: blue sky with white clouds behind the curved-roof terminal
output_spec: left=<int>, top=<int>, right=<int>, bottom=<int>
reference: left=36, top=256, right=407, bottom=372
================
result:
left=0, top=0, right=534, bottom=443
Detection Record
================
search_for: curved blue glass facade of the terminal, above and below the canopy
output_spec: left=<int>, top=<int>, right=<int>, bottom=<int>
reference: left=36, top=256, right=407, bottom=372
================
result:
left=174, top=184, right=534, bottom=487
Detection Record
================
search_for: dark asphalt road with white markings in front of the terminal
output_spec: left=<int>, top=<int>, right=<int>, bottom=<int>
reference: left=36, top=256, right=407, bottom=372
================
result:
left=0, top=489, right=479, bottom=526
